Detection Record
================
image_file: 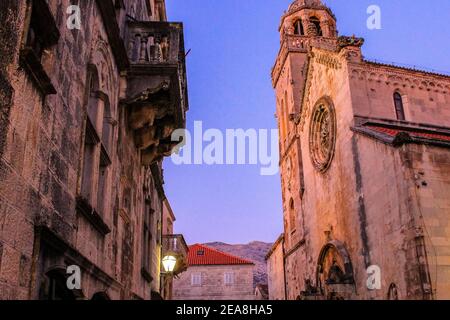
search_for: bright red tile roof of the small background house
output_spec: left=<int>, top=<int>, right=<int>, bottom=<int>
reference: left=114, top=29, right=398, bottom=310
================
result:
left=188, top=244, right=254, bottom=266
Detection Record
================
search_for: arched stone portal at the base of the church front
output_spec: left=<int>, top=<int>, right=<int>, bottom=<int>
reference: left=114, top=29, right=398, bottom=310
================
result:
left=316, top=240, right=355, bottom=299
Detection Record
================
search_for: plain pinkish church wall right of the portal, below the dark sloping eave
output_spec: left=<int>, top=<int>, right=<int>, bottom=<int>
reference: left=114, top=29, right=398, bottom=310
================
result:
left=355, top=137, right=422, bottom=299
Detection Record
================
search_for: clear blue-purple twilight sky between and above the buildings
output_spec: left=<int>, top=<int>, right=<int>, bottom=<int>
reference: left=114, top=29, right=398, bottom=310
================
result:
left=164, top=0, right=450, bottom=244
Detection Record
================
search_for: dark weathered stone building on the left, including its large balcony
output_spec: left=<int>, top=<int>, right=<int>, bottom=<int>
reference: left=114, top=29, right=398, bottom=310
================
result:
left=0, top=0, right=188, bottom=299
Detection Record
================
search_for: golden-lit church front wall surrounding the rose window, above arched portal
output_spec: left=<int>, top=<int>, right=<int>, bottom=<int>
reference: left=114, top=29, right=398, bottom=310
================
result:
left=299, top=49, right=367, bottom=298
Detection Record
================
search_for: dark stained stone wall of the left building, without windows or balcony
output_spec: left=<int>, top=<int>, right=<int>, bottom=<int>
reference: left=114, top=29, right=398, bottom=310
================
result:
left=0, top=0, right=173, bottom=299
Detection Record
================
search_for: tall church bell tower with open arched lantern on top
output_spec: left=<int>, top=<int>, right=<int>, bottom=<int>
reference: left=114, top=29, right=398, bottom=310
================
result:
left=272, top=0, right=337, bottom=296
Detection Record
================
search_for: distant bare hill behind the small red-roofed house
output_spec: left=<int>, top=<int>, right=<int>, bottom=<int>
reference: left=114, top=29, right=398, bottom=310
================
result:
left=205, top=241, right=272, bottom=287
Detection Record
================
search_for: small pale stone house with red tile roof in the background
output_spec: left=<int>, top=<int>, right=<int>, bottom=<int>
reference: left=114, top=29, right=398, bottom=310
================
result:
left=173, top=244, right=255, bottom=300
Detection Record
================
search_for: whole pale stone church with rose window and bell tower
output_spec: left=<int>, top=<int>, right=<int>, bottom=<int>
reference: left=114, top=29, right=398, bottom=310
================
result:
left=269, top=0, right=450, bottom=299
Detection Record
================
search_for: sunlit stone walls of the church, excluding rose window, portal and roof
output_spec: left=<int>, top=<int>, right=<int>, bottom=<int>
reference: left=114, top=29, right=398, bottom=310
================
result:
left=269, top=25, right=449, bottom=299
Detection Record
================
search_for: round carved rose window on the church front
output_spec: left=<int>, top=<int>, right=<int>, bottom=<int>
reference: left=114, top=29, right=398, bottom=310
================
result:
left=309, top=98, right=336, bottom=172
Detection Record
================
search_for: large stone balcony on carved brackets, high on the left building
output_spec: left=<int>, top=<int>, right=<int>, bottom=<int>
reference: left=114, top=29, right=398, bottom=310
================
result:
left=122, top=21, right=189, bottom=165
